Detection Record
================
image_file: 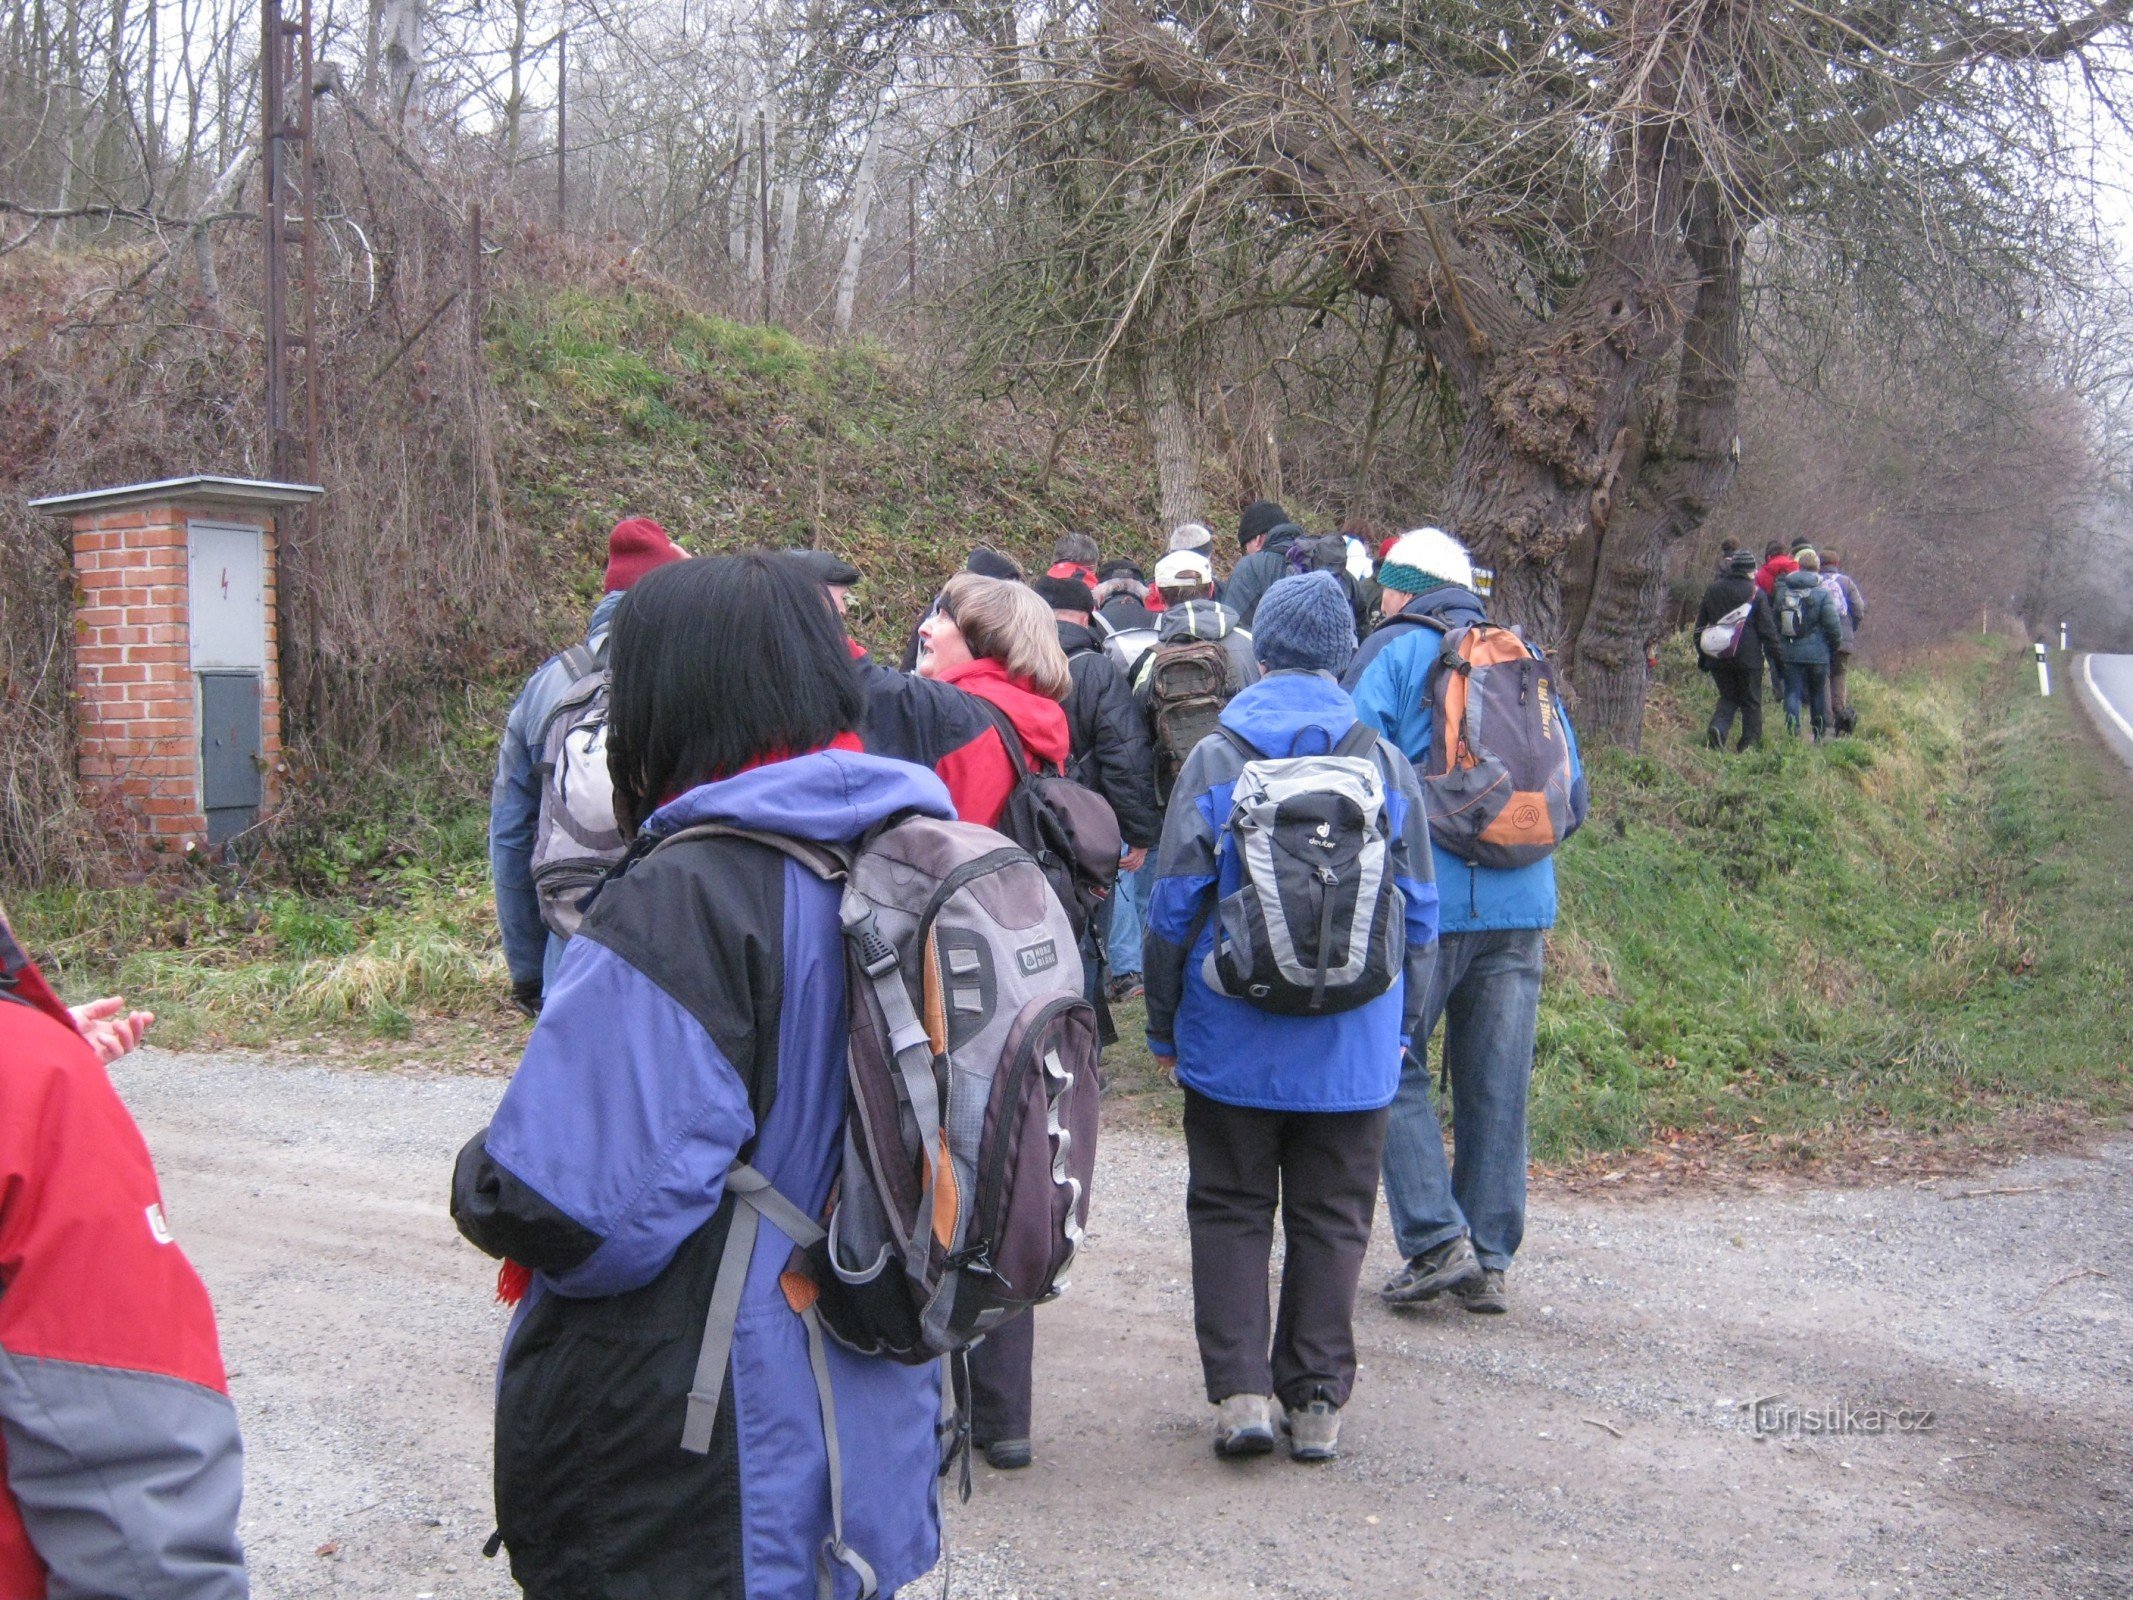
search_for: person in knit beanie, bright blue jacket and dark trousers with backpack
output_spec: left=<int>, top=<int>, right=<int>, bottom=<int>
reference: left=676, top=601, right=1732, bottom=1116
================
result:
left=1148, top=572, right=1436, bottom=1461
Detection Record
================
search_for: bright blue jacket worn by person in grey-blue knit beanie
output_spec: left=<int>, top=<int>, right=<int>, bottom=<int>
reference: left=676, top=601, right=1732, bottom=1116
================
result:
left=1141, top=672, right=1438, bottom=1111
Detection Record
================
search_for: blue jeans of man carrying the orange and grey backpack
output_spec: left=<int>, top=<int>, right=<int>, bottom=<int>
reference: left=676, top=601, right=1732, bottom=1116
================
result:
left=1384, top=928, right=1540, bottom=1269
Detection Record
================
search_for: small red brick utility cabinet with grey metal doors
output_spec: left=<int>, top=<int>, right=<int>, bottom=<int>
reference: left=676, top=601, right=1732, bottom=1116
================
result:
left=30, top=478, right=322, bottom=851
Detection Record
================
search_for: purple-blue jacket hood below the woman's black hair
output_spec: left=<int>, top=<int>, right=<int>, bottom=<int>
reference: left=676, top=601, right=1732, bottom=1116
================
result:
left=644, top=751, right=956, bottom=845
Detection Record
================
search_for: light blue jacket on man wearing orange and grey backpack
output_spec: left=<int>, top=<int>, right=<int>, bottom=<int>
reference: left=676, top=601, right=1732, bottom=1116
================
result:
left=1354, top=589, right=1585, bottom=934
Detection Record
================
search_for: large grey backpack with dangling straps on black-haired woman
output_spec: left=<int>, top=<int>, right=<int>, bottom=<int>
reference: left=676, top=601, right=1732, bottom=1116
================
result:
left=657, top=817, right=1096, bottom=1596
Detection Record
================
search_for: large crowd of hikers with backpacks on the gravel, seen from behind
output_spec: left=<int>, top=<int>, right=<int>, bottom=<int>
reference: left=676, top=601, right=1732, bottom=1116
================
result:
left=452, top=501, right=1587, bottom=1596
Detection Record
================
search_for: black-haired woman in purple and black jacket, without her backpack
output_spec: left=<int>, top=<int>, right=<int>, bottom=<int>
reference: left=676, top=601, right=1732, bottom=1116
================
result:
left=452, top=555, right=953, bottom=1600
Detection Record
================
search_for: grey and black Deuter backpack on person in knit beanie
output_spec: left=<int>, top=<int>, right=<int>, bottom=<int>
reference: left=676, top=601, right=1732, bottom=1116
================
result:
left=1188, top=723, right=1408, bottom=1015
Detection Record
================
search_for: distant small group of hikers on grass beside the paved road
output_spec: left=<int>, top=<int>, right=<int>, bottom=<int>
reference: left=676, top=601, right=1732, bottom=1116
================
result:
left=1696, top=540, right=1866, bottom=751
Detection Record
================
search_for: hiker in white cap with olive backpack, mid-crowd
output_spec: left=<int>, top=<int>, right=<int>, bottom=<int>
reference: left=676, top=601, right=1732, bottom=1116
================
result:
left=1109, top=554, right=1258, bottom=998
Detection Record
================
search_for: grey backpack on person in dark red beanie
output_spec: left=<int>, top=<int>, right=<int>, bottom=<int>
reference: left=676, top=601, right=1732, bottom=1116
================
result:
left=531, top=636, right=629, bottom=939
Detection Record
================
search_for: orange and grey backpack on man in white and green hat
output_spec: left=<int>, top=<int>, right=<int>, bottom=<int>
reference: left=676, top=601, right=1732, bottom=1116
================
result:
left=1418, top=617, right=1585, bottom=866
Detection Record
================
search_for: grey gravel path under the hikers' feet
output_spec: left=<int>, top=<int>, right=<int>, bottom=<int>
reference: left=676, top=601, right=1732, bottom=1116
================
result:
left=115, top=1052, right=2133, bottom=1600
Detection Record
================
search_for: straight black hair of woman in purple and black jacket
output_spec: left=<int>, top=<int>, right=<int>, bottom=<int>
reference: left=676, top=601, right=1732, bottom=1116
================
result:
left=608, top=550, right=866, bottom=834
